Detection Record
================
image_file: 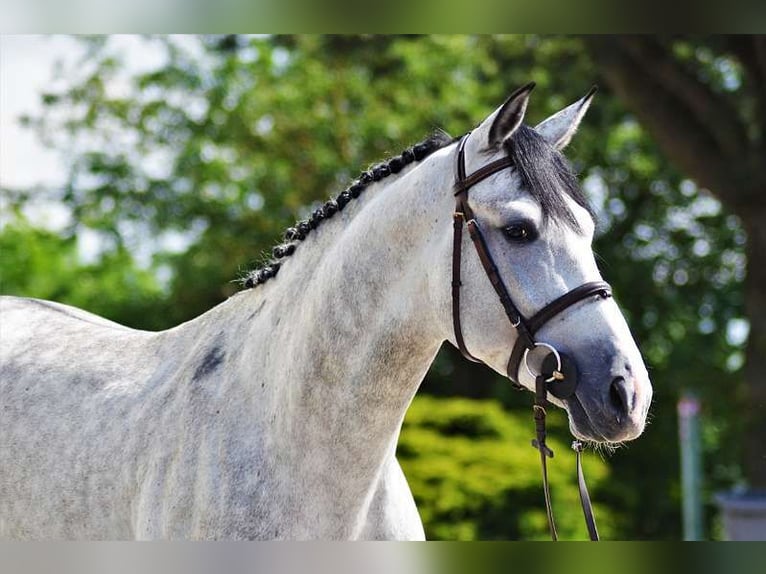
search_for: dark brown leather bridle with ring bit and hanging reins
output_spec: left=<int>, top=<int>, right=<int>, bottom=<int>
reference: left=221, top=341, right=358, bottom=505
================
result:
left=452, top=132, right=612, bottom=540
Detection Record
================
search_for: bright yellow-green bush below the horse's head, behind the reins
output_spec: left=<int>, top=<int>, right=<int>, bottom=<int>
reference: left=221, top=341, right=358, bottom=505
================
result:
left=397, top=395, right=614, bottom=540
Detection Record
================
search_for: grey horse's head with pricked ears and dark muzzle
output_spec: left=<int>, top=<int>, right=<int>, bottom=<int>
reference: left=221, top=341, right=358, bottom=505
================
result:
left=450, top=85, right=652, bottom=442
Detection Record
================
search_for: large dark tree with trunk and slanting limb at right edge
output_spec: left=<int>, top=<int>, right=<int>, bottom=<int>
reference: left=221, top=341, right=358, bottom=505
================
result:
left=586, top=36, right=766, bottom=489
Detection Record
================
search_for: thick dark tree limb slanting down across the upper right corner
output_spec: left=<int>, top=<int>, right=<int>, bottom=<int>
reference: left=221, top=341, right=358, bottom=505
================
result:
left=585, top=36, right=766, bottom=213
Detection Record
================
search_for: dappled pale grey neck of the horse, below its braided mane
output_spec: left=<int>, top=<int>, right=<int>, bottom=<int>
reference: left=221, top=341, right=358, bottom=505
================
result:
left=239, top=150, right=452, bottom=520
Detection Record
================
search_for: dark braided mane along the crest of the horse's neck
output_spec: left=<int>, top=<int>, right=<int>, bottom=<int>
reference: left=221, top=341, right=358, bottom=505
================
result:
left=241, top=131, right=455, bottom=289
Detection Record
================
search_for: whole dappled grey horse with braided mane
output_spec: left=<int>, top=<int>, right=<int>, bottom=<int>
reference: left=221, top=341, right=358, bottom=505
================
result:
left=0, top=85, right=652, bottom=540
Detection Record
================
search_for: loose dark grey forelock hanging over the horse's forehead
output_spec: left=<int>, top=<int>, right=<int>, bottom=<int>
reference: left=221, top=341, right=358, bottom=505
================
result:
left=505, top=125, right=595, bottom=231
